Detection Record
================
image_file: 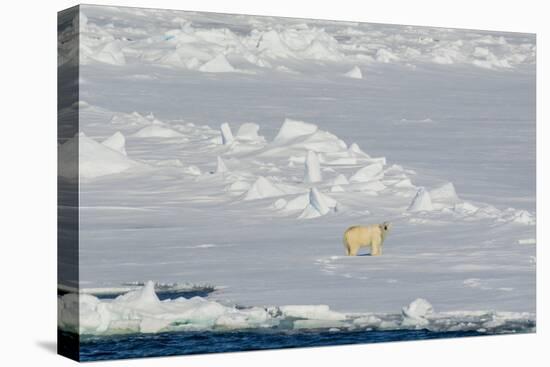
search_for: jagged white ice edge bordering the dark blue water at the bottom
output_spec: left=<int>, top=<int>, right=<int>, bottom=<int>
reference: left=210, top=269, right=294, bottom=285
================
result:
left=58, top=281, right=535, bottom=335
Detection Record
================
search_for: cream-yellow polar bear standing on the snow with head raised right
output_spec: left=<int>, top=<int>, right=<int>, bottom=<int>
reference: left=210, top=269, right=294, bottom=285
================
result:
left=344, top=222, right=391, bottom=256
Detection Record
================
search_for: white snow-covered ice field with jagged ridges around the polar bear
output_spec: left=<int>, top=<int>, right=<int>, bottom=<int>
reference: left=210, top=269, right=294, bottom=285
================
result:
left=59, top=5, right=536, bottom=333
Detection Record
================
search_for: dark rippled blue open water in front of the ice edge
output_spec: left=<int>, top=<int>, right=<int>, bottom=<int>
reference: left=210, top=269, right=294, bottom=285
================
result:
left=71, top=330, right=487, bottom=361
